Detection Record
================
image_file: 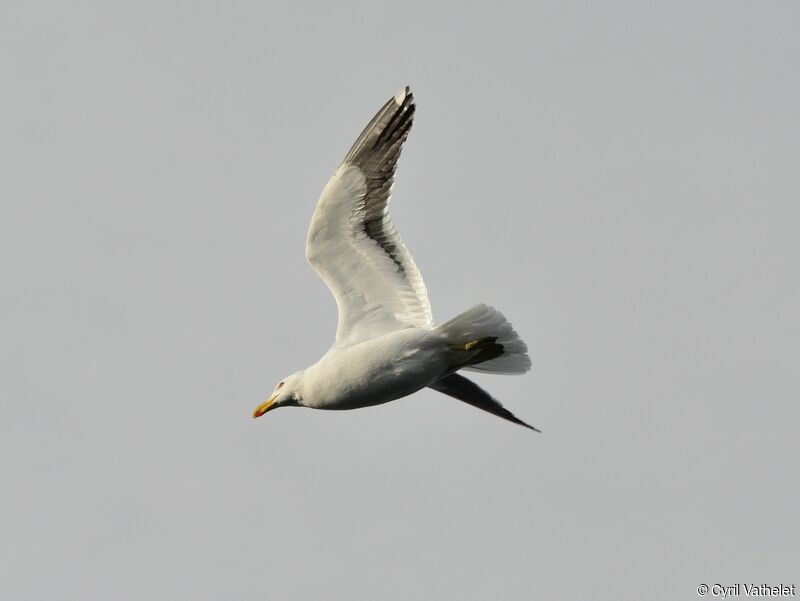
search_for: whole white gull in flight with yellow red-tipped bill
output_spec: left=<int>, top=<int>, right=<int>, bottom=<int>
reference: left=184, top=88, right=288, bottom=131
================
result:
left=253, top=86, right=539, bottom=432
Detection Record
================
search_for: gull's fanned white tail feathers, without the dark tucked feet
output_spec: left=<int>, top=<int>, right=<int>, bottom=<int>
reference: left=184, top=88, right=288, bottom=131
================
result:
left=436, top=304, right=531, bottom=374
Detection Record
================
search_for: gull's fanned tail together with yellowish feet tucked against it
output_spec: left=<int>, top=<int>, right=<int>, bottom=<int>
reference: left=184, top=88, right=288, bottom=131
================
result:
left=436, top=304, right=531, bottom=372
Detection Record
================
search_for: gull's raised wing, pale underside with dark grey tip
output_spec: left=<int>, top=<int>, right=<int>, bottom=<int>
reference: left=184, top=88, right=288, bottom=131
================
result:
left=306, top=87, right=433, bottom=344
